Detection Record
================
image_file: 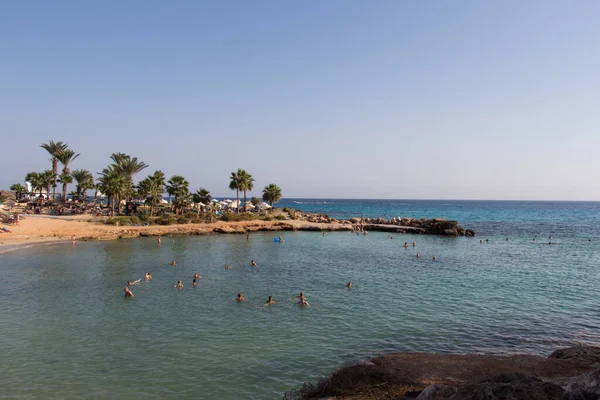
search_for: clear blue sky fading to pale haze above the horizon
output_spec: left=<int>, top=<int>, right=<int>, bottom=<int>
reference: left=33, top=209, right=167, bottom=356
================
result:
left=0, top=0, right=600, bottom=200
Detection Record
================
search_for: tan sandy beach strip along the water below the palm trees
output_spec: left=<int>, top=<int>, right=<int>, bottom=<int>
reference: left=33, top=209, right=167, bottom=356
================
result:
left=0, top=215, right=352, bottom=249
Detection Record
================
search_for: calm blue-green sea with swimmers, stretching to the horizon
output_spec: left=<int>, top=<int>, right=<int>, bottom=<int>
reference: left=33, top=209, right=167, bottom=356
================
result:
left=0, top=199, right=600, bottom=400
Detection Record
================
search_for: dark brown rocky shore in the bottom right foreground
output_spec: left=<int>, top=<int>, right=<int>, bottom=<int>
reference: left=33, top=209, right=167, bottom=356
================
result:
left=284, top=346, right=600, bottom=400
